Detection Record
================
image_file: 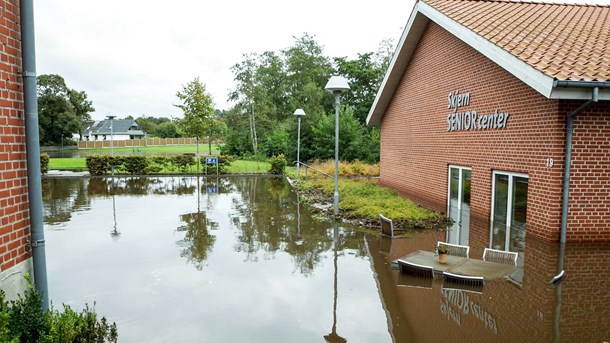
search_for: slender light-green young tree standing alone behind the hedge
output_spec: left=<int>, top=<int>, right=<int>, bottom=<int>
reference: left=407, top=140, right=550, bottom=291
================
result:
left=174, top=77, right=216, bottom=155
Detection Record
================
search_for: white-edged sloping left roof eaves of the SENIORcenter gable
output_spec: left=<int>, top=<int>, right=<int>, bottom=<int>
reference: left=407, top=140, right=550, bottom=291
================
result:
left=366, top=1, right=429, bottom=126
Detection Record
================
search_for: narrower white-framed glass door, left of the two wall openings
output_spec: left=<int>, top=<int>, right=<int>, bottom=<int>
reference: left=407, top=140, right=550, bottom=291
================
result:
left=447, top=166, right=471, bottom=245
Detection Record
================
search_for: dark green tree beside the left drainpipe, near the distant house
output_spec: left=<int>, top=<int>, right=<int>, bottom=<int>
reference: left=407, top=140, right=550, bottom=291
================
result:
left=37, top=75, right=81, bottom=145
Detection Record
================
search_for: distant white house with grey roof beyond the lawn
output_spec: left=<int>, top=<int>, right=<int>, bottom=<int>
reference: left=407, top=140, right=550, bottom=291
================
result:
left=83, top=119, right=146, bottom=141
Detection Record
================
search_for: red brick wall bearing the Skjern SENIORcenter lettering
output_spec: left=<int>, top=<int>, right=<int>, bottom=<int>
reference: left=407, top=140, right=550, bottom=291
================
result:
left=381, top=22, right=610, bottom=245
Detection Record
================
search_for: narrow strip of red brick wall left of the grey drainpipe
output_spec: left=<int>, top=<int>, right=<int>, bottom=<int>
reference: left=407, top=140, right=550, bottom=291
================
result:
left=0, top=1, right=30, bottom=272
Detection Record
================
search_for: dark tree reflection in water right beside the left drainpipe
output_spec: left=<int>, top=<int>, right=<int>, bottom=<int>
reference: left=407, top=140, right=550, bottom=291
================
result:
left=42, top=178, right=91, bottom=224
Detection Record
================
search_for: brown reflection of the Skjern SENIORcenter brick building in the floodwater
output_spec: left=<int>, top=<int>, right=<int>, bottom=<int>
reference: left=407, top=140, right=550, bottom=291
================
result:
left=367, top=234, right=610, bottom=342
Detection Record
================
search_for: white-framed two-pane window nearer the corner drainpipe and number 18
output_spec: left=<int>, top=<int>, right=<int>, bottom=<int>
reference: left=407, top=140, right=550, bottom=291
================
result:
left=490, top=171, right=528, bottom=252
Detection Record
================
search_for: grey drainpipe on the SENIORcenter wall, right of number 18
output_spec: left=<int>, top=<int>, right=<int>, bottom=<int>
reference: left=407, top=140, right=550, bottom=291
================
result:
left=559, top=87, right=599, bottom=246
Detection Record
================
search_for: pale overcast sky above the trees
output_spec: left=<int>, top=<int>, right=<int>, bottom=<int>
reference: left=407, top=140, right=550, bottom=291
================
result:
left=34, top=0, right=414, bottom=119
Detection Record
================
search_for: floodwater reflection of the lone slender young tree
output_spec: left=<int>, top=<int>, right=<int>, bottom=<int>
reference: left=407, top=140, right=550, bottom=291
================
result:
left=176, top=212, right=218, bottom=270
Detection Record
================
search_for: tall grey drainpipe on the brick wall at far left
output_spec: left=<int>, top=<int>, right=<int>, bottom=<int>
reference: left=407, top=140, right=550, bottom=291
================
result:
left=19, top=0, right=49, bottom=311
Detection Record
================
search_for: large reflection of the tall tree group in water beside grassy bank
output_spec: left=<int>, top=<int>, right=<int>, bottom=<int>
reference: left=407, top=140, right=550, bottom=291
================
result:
left=233, top=178, right=366, bottom=275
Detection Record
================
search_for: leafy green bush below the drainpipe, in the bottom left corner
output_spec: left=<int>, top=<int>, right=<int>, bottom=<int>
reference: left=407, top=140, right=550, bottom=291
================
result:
left=0, top=276, right=118, bottom=343
